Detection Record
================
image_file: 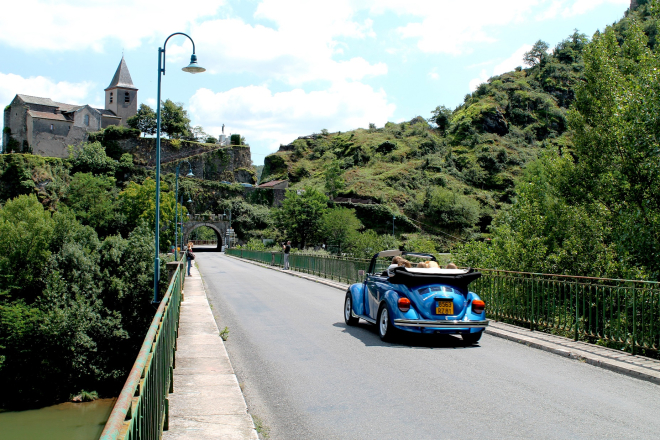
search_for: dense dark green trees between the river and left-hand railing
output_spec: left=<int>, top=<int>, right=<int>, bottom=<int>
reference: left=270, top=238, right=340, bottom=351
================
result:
left=0, top=195, right=164, bottom=408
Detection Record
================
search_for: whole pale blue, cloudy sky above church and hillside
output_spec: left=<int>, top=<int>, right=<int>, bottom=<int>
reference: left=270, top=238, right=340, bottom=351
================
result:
left=0, top=0, right=630, bottom=165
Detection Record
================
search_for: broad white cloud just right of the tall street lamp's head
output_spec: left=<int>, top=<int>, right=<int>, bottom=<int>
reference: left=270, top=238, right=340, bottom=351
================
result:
left=168, top=7, right=387, bottom=85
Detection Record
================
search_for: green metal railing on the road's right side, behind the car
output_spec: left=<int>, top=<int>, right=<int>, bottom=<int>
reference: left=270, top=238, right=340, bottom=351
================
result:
left=227, top=249, right=660, bottom=356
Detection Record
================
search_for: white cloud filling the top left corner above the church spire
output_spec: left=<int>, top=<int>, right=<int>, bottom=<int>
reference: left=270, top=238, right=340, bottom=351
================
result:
left=0, top=0, right=224, bottom=51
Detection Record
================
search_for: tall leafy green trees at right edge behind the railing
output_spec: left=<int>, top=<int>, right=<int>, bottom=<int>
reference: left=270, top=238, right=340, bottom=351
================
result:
left=458, top=1, right=660, bottom=280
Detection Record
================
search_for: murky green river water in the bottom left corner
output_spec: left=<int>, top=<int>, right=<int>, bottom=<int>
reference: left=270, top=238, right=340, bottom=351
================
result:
left=0, top=399, right=117, bottom=440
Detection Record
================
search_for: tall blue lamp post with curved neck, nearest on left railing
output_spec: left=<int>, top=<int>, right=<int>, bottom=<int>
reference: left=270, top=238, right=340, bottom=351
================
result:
left=153, top=32, right=206, bottom=304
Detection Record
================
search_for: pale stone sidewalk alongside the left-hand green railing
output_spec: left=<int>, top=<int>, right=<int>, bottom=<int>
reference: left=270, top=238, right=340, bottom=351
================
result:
left=162, top=267, right=258, bottom=440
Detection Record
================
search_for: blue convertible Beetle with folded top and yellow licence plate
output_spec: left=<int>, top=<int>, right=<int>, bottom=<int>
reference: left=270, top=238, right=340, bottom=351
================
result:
left=344, top=250, right=488, bottom=344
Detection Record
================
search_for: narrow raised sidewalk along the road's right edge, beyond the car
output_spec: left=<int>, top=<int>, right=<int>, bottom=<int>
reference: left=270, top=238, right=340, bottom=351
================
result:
left=228, top=255, right=660, bottom=385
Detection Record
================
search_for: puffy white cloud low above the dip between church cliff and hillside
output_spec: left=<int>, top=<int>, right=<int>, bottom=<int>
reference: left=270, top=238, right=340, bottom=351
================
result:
left=189, top=82, right=395, bottom=153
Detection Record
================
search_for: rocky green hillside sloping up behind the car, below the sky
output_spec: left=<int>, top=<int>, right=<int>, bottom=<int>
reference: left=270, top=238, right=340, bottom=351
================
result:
left=261, top=31, right=587, bottom=244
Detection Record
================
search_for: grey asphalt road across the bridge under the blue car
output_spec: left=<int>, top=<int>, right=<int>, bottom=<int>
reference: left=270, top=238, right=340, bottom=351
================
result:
left=196, top=253, right=660, bottom=440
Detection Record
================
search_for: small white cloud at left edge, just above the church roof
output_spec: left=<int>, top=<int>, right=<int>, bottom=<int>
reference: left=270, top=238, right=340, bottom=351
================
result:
left=0, top=72, right=95, bottom=108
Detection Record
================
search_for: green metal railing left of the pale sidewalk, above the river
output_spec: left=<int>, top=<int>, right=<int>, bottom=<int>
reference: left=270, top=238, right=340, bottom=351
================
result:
left=101, top=259, right=185, bottom=440
